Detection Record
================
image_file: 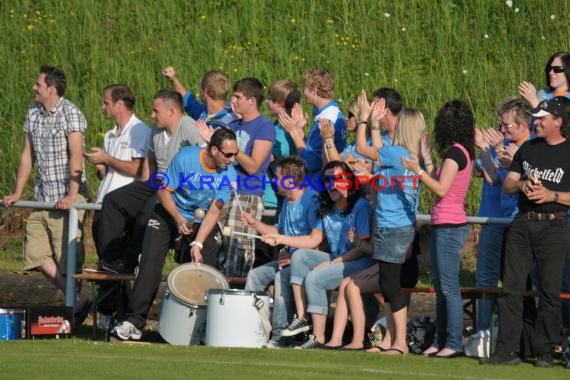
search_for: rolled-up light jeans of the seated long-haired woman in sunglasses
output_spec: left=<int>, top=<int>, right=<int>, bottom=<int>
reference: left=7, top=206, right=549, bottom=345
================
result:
left=291, top=249, right=375, bottom=315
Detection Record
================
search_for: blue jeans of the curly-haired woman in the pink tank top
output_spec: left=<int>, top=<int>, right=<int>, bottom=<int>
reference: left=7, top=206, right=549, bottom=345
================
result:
left=431, top=225, right=469, bottom=351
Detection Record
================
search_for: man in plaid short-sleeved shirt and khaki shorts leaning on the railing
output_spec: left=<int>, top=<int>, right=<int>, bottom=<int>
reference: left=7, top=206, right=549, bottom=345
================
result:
left=4, top=66, right=89, bottom=323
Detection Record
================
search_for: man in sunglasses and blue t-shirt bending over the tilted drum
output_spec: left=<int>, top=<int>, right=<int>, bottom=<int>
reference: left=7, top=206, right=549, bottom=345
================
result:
left=112, top=128, right=236, bottom=340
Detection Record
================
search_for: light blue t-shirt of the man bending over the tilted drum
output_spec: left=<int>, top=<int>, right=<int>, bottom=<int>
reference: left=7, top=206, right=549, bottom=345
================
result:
left=167, top=146, right=236, bottom=221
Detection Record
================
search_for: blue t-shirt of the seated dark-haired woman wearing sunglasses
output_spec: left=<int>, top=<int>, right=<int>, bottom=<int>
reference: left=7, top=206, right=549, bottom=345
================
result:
left=314, top=198, right=372, bottom=259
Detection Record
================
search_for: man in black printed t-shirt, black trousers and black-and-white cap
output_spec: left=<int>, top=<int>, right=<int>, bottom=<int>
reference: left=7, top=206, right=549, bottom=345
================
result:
left=481, top=97, right=570, bottom=367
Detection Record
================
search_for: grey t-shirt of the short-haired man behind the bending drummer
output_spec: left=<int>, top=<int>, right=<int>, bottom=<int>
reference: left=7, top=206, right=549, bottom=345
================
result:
left=148, top=116, right=206, bottom=172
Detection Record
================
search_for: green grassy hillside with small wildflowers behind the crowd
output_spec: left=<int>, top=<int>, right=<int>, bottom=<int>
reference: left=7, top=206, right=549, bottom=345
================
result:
left=0, top=0, right=570, bottom=214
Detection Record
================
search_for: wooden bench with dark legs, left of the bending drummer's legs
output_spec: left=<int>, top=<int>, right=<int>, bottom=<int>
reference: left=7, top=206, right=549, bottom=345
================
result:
left=73, top=271, right=135, bottom=338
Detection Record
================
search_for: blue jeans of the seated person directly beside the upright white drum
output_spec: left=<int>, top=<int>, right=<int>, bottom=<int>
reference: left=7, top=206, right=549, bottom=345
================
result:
left=245, top=261, right=293, bottom=340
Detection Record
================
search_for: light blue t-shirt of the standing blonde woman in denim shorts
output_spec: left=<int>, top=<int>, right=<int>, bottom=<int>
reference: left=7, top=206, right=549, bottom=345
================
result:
left=376, top=145, right=421, bottom=228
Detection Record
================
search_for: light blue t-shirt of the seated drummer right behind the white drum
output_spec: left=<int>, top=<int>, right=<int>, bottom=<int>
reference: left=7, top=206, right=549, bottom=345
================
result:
left=277, top=189, right=319, bottom=252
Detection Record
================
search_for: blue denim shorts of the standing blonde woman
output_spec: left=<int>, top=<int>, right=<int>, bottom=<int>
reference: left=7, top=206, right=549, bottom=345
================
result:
left=373, top=225, right=416, bottom=264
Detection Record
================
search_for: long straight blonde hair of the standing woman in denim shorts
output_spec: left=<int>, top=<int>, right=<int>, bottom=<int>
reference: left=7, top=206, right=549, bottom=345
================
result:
left=394, top=108, right=426, bottom=159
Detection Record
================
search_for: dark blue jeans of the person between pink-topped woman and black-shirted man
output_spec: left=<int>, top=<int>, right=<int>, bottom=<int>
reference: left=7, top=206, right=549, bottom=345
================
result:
left=475, top=224, right=508, bottom=331
